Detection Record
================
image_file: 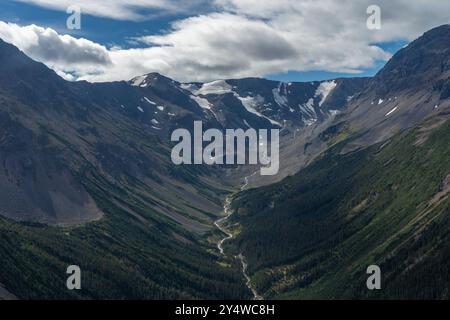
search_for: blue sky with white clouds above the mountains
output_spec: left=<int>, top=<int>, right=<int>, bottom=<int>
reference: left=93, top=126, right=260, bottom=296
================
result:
left=0, top=0, right=450, bottom=82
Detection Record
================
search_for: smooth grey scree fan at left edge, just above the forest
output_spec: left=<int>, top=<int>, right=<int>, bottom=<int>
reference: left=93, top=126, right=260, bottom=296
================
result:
left=0, top=112, right=102, bottom=224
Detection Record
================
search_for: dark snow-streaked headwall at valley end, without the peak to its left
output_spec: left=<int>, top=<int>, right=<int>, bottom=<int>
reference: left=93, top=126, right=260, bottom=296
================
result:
left=182, top=78, right=368, bottom=128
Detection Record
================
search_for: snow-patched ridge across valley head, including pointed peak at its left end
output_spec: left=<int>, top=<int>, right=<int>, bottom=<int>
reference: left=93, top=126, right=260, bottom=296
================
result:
left=129, top=73, right=368, bottom=128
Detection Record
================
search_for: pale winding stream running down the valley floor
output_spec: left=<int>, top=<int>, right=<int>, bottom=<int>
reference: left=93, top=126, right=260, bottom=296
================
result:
left=214, top=172, right=263, bottom=300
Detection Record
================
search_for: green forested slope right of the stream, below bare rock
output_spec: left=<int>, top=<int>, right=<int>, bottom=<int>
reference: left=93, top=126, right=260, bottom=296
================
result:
left=229, top=111, right=450, bottom=298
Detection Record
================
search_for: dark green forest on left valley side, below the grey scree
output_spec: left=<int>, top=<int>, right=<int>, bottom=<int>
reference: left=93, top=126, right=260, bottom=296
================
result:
left=0, top=166, right=250, bottom=299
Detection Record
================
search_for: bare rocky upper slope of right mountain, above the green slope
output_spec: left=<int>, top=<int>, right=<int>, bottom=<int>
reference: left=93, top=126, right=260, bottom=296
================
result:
left=342, top=25, right=450, bottom=149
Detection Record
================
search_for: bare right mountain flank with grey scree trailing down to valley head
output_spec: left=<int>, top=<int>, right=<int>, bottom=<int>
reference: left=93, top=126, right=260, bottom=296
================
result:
left=243, top=25, right=450, bottom=186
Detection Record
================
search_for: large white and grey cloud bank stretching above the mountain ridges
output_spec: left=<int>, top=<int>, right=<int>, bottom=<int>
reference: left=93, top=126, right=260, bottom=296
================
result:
left=0, top=0, right=450, bottom=81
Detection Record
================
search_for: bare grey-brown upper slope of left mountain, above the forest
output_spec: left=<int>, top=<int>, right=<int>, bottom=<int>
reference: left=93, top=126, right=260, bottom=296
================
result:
left=0, top=39, right=220, bottom=228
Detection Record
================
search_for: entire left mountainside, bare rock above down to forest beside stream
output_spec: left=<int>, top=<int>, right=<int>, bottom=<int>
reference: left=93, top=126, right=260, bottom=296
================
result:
left=0, top=42, right=250, bottom=299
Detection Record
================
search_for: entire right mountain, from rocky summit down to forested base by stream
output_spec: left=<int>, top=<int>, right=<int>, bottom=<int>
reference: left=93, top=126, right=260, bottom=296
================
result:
left=227, top=25, right=450, bottom=299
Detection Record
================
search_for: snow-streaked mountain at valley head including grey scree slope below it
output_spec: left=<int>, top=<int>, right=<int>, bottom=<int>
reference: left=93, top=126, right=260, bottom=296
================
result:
left=176, top=74, right=370, bottom=186
